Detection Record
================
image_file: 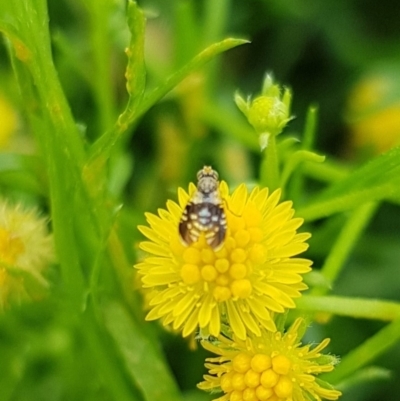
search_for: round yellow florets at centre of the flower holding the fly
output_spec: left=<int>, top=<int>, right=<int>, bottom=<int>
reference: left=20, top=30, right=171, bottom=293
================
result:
left=180, top=202, right=266, bottom=302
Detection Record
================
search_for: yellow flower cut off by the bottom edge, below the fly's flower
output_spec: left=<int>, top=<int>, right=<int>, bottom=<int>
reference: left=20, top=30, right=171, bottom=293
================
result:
left=198, top=319, right=341, bottom=401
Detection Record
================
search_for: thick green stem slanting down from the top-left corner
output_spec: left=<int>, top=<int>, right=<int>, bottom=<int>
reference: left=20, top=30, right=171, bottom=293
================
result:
left=1, top=0, right=91, bottom=309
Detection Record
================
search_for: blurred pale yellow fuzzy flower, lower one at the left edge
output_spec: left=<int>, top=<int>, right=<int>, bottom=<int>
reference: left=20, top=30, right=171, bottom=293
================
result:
left=0, top=200, right=54, bottom=309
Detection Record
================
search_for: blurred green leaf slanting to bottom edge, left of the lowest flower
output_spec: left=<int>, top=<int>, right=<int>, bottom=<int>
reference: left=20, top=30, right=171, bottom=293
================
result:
left=104, top=303, right=181, bottom=401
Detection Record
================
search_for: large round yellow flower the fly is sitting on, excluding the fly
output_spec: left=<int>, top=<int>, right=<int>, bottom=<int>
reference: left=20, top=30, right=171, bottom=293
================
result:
left=136, top=182, right=311, bottom=339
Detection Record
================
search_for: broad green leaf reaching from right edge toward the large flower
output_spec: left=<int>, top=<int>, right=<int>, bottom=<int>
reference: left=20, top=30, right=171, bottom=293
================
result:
left=297, top=146, right=400, bottom=221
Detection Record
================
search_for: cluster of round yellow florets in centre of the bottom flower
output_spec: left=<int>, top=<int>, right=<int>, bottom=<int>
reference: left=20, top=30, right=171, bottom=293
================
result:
left=221, top=353, right=293, bottom=401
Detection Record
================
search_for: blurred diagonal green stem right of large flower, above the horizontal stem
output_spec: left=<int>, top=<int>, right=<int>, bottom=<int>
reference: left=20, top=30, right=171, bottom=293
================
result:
left=312, top=203, right=378, bottom=295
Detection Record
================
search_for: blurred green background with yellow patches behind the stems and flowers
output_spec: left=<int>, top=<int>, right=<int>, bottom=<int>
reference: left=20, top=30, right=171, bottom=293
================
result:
left=0, top=0, right=400, bottom=401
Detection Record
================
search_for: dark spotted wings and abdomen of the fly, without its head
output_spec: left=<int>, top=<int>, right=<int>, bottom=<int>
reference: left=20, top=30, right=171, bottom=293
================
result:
left=179, top=202, right=226, bottom=249
